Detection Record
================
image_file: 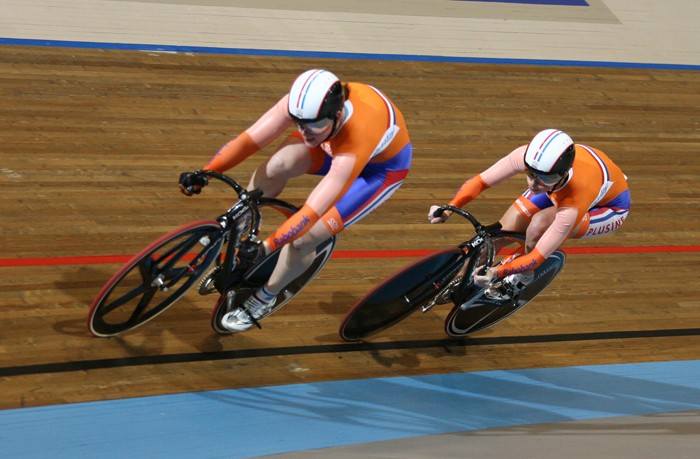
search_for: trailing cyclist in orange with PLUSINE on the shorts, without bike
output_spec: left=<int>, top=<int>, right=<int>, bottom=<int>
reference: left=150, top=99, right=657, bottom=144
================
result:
left=428, top=129, right=630, bottom=300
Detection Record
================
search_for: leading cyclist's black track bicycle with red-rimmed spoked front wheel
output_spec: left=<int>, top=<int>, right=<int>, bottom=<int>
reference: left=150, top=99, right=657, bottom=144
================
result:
left=87, top=170, right=337, bottom=337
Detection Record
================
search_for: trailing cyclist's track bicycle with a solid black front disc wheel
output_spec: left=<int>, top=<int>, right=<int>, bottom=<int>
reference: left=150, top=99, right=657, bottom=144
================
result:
left=340, top=205, right=566, bottom=341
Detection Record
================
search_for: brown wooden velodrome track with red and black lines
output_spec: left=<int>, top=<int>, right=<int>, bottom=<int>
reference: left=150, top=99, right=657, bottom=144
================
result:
left=0, top=41, right=700, bottom=409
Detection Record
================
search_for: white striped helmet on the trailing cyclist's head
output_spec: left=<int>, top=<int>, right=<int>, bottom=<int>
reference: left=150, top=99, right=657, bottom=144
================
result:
left=525, top=129, right=576, bottom=182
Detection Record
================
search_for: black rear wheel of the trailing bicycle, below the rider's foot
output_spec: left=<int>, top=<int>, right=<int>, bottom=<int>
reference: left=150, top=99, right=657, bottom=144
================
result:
left=445, top=251, right=566, bottom=338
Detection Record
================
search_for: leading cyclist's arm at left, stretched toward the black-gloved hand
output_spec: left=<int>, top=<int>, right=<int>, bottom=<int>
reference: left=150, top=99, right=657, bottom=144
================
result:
left=204, top=95, right=292, bottom=172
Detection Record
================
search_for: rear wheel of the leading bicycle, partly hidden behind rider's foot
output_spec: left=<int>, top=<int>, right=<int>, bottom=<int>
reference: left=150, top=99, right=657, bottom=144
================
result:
left=211, top=235, right=338, bottom=335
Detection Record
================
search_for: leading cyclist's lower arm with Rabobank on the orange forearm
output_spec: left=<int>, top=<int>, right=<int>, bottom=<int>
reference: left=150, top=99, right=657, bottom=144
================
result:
left=265, top=154, right=362, bottom=252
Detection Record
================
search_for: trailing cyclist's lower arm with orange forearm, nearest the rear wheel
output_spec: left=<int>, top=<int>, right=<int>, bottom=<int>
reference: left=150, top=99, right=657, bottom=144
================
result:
left=496, top=207, right=578, bottom=277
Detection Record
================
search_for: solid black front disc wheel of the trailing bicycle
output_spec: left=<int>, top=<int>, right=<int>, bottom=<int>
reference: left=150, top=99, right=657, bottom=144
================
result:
left=340, top=248, right=467, bottom=341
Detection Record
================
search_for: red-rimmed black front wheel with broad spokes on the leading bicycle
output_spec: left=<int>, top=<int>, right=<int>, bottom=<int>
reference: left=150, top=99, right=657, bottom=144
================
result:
left=88, top=221, right=223, bottom=337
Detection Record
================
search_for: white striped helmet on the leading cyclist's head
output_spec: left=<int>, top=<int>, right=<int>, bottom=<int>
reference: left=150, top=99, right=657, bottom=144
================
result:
left=289, top=69, right=344, bottom=123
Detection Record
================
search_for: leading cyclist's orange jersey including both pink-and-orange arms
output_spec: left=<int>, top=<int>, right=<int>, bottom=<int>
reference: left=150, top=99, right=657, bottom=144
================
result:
left=205, top=83, right=410, bottom=250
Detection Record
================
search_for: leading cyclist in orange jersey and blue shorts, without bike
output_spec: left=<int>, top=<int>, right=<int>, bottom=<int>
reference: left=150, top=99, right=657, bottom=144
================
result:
left=180, top=69, right=412, bottom=332
